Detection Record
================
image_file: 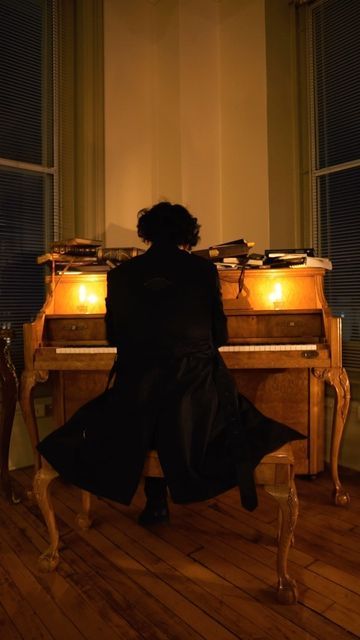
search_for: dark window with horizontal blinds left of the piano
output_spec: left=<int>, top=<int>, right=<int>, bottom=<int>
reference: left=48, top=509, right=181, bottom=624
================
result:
left=0, top=0, right=58, bottom=373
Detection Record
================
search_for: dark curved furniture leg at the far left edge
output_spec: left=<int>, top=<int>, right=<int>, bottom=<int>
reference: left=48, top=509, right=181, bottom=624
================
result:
left=0, top=337, right=19, bottom=503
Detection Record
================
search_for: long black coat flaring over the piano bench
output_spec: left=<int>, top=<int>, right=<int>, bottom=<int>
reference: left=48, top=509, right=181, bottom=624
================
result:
left=38, top=244, right=303, bottom=509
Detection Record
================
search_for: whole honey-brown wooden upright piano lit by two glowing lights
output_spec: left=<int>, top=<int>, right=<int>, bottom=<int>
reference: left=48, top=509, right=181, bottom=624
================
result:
left=20, top=268, right=350, bottom=505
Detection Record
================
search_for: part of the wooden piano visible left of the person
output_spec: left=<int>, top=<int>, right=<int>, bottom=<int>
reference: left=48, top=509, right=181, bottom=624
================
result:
left=20, top=272, right=115, bottom=444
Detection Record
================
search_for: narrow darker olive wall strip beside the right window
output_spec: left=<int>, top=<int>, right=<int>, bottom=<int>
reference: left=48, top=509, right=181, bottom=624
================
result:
left=265, top=0, right=300, bottom=248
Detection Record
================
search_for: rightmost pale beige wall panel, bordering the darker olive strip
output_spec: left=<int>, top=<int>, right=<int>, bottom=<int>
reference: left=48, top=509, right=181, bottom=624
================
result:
left=219, top=0, right=269, bottom=251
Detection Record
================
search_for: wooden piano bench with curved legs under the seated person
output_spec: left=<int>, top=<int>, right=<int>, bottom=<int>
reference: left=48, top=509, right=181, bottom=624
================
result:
left=34, top=444, right=298, bottom=604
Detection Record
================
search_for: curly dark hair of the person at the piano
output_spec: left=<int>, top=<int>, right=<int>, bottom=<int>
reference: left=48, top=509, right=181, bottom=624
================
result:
left=137, top=201, right=200, bottom=247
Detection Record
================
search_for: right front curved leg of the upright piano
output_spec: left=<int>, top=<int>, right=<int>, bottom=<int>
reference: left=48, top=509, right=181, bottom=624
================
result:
left=313, top=367, right=350, bottom=507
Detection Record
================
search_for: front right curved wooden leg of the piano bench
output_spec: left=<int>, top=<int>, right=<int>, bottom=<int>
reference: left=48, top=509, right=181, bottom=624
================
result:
left=264, top=480, right=299, bottom=604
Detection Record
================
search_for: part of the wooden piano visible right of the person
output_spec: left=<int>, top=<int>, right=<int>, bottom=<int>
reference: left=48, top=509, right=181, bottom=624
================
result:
left=220, top=268, right=350, bottom=504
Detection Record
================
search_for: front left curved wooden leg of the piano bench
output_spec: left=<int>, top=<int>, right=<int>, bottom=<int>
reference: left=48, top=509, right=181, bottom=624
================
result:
left=33, top=461, right=59, bottom=572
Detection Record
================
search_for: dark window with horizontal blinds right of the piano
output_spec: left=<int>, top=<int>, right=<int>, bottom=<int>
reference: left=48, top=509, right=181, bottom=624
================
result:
left=307, top=0, right=360, bottom=372
